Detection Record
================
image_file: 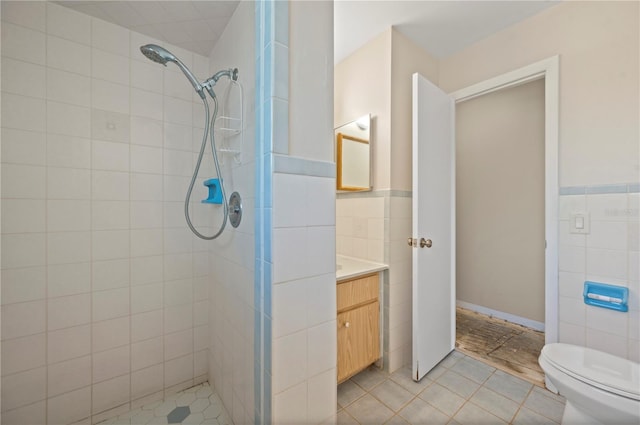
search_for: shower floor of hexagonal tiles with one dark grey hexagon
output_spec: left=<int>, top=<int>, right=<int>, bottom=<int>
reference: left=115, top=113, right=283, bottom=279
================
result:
left=99, top=383, right=233, bottom=425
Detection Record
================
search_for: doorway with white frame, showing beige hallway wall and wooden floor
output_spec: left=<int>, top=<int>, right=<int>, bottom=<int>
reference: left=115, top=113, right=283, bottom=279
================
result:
left=453, top=58, right=557, bottom=385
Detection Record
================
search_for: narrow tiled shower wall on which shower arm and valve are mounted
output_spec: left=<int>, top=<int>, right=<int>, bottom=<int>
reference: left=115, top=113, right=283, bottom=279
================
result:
left=201, top=2, right=256, bottom=424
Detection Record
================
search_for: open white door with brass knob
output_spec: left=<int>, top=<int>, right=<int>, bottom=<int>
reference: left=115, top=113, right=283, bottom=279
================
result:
left=408, top=74, right=456, bottom=381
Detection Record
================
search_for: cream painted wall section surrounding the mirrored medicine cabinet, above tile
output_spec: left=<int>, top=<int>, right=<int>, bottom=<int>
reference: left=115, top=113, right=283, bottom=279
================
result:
left=333, top=29, right=391, bottom=190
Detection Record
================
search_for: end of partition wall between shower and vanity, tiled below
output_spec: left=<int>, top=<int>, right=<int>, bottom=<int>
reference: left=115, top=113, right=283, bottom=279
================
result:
left=265, top=2, right=337, bottom=424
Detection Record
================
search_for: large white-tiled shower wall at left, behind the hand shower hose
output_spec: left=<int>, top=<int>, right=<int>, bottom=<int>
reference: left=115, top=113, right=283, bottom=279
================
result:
left=2, top=1, right=217, bottom=423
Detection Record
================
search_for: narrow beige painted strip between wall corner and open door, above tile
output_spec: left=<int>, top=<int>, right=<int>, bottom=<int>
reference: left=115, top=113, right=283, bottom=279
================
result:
left=391, top=30, right=438, bottom=190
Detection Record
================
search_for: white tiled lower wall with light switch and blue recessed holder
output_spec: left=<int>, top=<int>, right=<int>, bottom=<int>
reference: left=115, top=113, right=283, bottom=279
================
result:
left=558, top=183, right=640, bottom=362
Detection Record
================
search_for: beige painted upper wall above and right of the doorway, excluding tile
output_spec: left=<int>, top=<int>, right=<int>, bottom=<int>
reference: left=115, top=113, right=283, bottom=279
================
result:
left=439, top=2, right=640, bottom=186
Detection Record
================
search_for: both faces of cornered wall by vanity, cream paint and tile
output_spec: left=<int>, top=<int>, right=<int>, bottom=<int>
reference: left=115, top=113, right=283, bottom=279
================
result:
left=334, top=28, right=444, bottom=371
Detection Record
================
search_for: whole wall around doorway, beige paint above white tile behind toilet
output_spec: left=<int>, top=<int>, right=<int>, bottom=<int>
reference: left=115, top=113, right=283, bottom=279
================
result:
left=439, top=2, right=640, bottom=361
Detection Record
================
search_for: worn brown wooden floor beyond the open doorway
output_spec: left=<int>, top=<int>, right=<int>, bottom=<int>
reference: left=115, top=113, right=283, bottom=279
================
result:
left=456, top=307, right=544, bottom=388
